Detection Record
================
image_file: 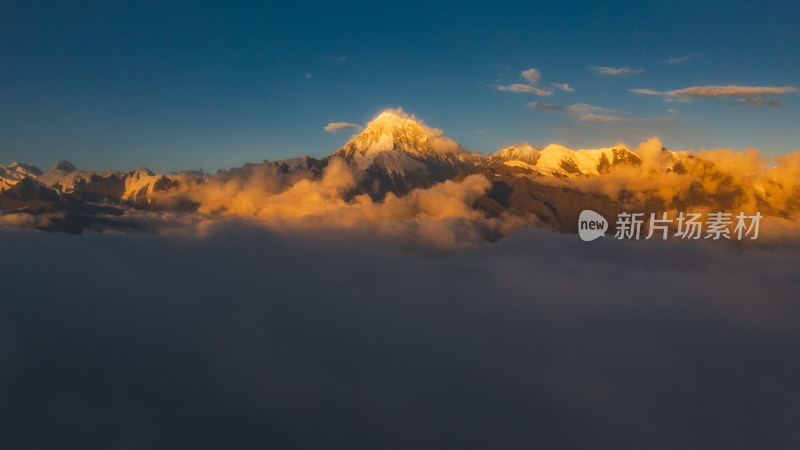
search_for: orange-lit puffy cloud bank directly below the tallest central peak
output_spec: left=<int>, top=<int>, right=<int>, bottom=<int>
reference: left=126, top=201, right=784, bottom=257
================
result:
left=149, top=158, right=524, bottom=248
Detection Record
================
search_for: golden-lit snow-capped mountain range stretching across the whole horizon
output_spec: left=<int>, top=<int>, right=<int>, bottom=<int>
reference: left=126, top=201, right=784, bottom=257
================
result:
left=0, top=110, right=800, bottom=236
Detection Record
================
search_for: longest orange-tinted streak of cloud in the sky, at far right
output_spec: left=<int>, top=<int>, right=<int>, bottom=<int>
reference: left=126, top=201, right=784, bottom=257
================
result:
left=629, top=85, right=797, bottom=106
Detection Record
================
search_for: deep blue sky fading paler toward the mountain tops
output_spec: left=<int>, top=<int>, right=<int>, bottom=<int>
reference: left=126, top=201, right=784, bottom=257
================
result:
left=0, top=0, right=800, bottom=171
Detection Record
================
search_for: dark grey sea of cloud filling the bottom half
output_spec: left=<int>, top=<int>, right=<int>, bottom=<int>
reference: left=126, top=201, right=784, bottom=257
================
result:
left=0, top=224, right=800, bottom=449
